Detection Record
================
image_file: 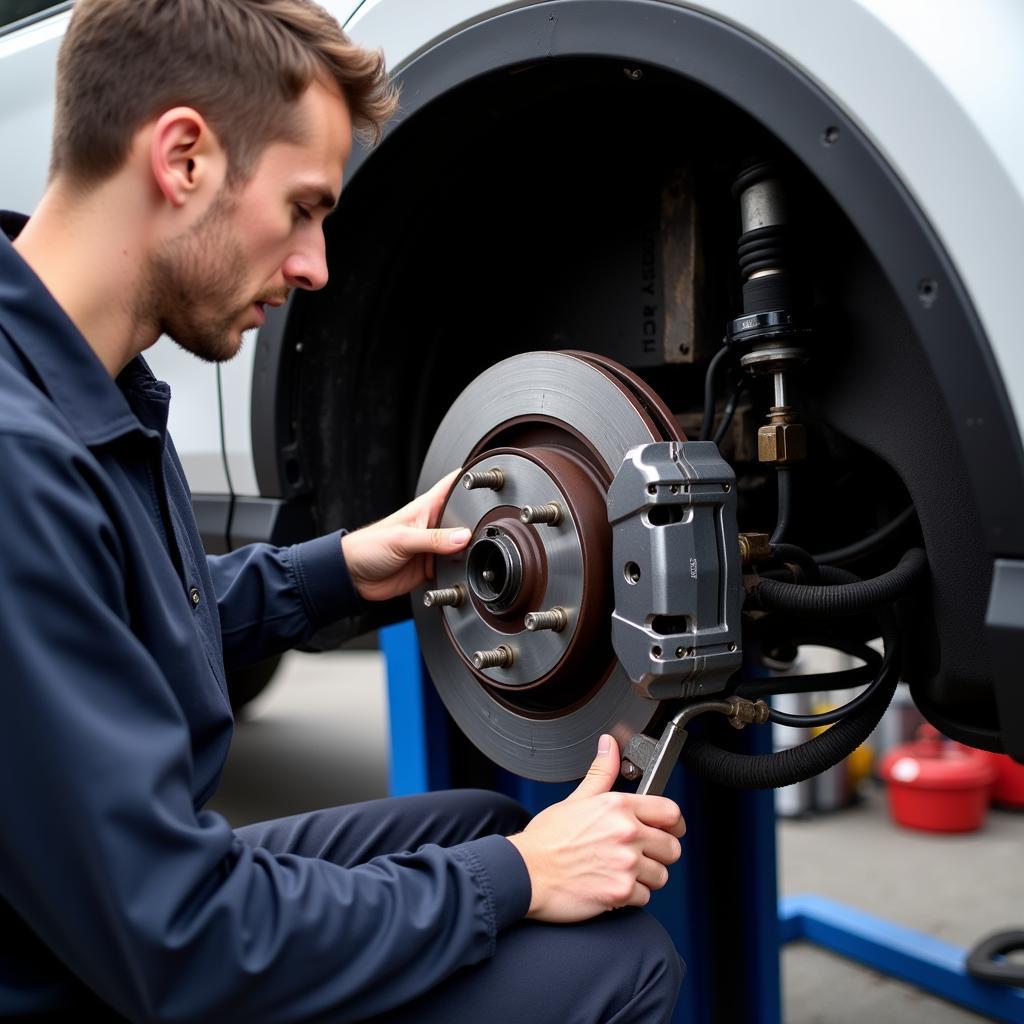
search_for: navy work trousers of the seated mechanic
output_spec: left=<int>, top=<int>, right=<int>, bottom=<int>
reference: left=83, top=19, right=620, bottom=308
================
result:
left=237, top=790, right=684, bottom=1024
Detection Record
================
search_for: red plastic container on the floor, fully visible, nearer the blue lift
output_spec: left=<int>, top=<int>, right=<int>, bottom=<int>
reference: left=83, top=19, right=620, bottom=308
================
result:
left=879, top=725, right=996, bottom=833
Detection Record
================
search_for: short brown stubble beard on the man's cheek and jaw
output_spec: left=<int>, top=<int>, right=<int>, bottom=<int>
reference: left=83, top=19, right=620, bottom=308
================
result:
left=135, top=189, right=253, bottom=362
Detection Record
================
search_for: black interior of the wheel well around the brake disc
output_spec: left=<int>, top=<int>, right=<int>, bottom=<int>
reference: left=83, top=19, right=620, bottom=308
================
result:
left=262, top=6, right=1016, bottom=743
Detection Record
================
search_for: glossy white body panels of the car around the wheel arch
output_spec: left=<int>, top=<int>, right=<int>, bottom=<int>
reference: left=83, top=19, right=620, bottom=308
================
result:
left=0, top=0, right=1024, bottom=496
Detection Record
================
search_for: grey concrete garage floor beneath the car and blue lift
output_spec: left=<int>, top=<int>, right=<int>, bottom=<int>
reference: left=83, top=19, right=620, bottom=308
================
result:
left=211, top=651, right=1024, bottom=1024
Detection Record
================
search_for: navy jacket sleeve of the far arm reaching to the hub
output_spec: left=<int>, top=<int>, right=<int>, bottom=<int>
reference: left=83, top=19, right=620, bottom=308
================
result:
left=206, top=530, right=362, bottom=670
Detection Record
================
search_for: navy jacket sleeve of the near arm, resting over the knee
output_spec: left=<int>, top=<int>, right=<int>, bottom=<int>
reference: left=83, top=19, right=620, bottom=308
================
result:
left=0, top=434, right=529, bottom=1022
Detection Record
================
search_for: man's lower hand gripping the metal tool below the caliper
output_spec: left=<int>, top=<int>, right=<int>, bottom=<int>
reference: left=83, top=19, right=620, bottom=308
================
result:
left=509, top=736, right=686, bottom=923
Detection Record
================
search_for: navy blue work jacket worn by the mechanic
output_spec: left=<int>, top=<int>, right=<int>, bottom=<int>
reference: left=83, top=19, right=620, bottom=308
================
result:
left=0, top=215, right=529, bottom=1024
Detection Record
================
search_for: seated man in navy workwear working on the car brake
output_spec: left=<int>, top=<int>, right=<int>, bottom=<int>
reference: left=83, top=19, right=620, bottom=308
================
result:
left=0, top=0, right=684, bottom=1024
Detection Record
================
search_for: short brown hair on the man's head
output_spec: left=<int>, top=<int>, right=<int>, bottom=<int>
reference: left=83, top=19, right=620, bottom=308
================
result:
left=50, top=0, right=397, bottom=186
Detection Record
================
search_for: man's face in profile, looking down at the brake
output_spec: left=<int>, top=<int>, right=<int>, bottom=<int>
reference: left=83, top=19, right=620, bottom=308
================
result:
left=144, top=82, right=352, bottom=362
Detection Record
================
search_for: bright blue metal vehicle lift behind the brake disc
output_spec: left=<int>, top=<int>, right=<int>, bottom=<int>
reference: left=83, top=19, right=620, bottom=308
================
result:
left=380, top=622, right=1024, bottom=1024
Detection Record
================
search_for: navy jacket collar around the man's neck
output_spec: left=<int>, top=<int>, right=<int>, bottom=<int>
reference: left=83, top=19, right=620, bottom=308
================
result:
left=0, top=211, right=164, bottom=446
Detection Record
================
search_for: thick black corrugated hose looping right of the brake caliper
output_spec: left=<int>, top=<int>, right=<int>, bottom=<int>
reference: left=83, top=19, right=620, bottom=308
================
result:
left=680, top=548, right=928, bottom=790
